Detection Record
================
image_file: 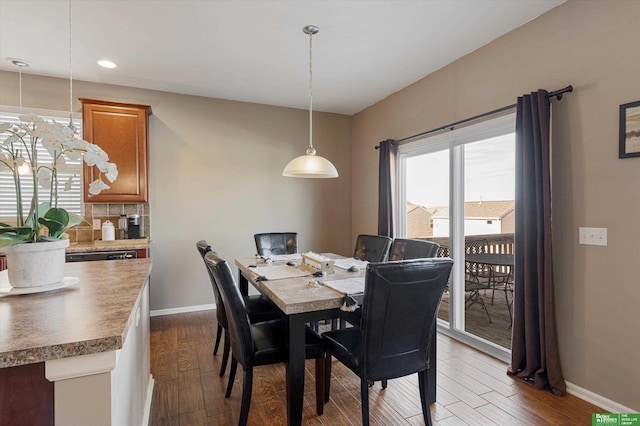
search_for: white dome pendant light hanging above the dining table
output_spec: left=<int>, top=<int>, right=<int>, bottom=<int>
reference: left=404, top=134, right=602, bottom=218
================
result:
left=282, top=25, right=338, bottom=178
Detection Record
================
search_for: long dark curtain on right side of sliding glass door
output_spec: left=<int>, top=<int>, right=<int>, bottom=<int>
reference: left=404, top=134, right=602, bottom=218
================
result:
left=509, top=90, right=566, bottom=395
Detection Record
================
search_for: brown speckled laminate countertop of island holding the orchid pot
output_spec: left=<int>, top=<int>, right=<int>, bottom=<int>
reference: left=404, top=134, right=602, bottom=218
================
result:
left=0, top=256, right=152, bottom=368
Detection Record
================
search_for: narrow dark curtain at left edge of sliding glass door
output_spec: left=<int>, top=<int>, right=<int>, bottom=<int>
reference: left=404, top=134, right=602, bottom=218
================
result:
left=378, top=139, right=398, bottom=238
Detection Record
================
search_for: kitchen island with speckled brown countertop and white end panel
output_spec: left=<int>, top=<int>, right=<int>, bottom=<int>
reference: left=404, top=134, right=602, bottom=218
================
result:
left=0, top=258, right=153, bottom=425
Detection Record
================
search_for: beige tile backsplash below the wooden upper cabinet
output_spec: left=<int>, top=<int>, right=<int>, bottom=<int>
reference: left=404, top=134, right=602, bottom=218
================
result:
left=68, top=203, right=151, bottom=243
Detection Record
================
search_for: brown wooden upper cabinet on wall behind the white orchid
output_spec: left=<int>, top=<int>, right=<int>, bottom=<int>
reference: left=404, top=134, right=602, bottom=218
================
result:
left=80, top=98, right=151, bottom=203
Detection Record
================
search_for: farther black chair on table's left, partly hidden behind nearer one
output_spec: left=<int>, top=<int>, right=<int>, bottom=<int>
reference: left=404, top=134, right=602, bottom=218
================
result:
left=196, top=240, right=282, bottom=377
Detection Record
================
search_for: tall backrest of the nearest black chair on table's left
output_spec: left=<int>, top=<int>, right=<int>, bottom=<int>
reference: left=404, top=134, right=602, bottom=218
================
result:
left=204, top=252, right=255, bottom=368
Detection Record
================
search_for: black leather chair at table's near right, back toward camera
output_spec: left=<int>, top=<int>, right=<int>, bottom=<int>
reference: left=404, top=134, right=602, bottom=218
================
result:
left=322, top=258, right=453, bottom=425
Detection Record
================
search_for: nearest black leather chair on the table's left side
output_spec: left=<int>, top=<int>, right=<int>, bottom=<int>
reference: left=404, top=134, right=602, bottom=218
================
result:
left=204, top=252, right=326, bottom=426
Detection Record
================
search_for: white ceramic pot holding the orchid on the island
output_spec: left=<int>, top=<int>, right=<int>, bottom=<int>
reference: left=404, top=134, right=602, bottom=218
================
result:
left=2, top=240, right=69, bottom=287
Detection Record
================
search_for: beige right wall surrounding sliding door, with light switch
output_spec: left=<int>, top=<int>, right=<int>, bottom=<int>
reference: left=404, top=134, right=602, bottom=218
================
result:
left=351, top=0, right=640, bottom=411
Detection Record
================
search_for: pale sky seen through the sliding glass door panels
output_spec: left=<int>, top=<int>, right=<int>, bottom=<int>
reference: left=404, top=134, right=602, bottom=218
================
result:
left=406, top=133, right=515, bottom=207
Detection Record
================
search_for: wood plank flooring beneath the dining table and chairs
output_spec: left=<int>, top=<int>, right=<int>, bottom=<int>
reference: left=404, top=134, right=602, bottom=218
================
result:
left=150, top=311, right=602, bottom=426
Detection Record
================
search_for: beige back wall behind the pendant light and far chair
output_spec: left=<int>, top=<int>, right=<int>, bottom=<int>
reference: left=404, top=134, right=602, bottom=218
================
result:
left=0, top=70, right=353, bottom=310
